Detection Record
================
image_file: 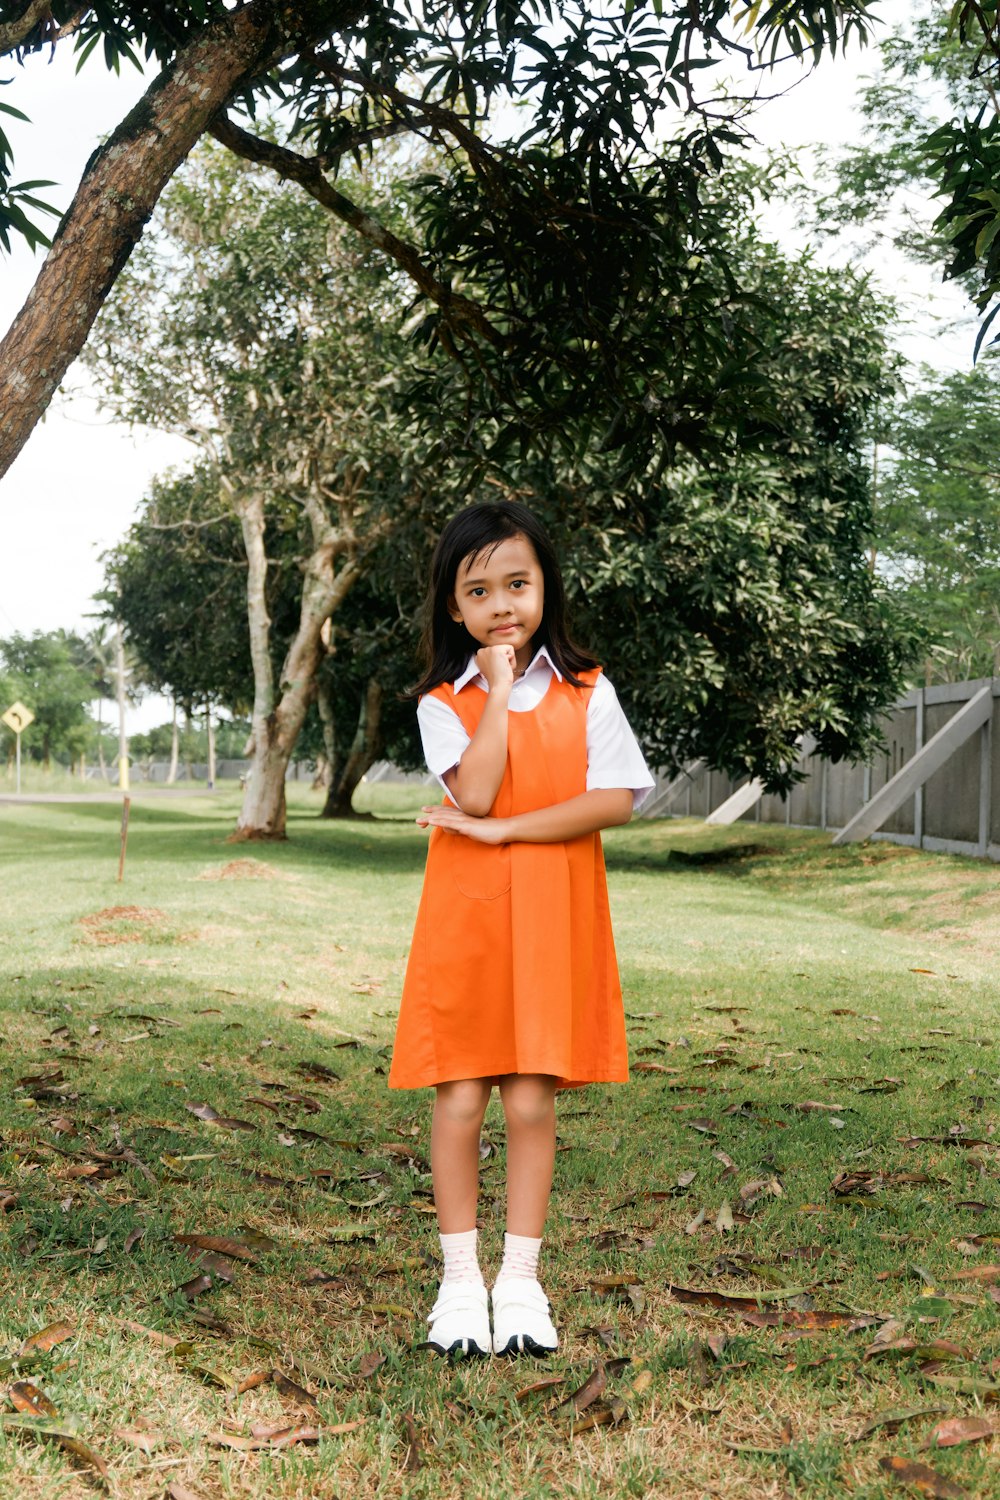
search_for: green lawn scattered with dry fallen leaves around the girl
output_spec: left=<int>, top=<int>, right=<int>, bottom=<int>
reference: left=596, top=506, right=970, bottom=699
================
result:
left=0, top=788, right=1000, bottom=1500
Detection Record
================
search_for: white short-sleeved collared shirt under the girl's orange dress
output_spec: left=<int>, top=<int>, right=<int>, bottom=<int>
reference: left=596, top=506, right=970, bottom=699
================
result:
left=417, top=647, right=654, bottom=807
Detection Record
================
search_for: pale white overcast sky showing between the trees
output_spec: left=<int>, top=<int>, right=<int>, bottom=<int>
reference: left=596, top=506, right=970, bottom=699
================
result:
left=0, top=0, right=972, bottom=732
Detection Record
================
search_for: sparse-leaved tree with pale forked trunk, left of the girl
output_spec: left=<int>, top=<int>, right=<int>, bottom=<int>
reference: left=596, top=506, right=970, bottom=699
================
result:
left=91, top=149, right=433, bottom=837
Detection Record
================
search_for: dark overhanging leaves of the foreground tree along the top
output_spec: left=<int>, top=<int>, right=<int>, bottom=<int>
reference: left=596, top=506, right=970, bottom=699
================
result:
left=0, top=0, right=893, bottom=473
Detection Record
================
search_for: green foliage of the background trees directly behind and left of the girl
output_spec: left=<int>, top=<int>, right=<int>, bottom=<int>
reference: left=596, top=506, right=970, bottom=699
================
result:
left=93, top=141, right=913, bottom=786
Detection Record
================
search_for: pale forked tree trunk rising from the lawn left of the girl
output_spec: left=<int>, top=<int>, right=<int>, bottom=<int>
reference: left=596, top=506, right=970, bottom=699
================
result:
left=229, top=507, right=360, bottom=843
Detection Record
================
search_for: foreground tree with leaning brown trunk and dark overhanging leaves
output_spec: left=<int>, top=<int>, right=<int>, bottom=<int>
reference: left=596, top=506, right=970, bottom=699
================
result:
left=0, top=0, right=877, bottom=474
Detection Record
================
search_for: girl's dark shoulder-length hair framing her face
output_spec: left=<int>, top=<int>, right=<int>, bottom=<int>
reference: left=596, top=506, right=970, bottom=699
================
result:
left=409, top=500, right=597, bottom=698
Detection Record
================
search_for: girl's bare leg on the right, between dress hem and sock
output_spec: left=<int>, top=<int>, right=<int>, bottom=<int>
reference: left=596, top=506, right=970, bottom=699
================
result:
left=499, top=1073, right=556, bottom=1239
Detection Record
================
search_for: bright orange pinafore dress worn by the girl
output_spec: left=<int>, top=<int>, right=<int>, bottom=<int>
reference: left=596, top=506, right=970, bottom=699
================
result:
left=388, top=668, right=628, bottom=1089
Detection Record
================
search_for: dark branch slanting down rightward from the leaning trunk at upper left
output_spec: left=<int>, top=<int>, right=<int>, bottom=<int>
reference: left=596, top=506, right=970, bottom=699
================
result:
left=210, top=113, right=504, bottom=347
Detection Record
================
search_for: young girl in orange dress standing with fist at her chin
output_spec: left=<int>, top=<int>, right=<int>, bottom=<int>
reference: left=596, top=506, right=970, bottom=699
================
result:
left=388, top=501, right=652, bottom=1355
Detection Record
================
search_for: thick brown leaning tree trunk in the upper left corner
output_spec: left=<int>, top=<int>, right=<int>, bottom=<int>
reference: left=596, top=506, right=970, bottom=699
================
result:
left=0, top=0, right=280, bottom=476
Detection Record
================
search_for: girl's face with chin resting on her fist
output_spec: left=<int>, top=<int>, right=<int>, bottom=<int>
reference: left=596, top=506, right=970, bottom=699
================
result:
left=448, top=536, right=546, bottom=668
